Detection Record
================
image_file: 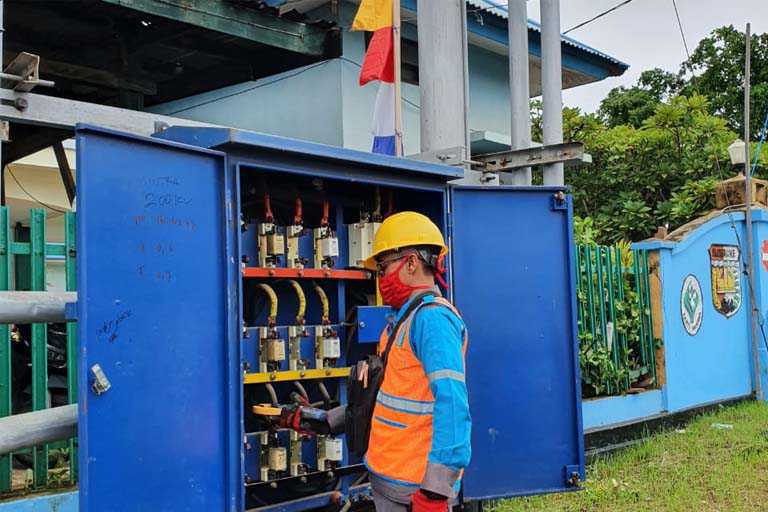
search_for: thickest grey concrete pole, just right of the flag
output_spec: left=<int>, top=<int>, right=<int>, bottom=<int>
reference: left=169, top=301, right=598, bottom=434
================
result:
left=417, top=0, right=469, bottom=157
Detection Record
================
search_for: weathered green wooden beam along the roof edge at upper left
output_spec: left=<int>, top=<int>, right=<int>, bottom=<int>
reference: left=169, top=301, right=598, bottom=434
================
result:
left=101, top=0, right=328, bottom=57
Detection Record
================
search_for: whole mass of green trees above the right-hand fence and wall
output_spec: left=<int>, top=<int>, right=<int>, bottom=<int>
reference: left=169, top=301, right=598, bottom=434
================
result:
left=552, top=26, right=768, bottom=244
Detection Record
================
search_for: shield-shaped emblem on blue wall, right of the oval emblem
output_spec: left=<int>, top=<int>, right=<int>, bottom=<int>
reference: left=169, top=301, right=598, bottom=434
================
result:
left=709, top=244, right=741, bottom=318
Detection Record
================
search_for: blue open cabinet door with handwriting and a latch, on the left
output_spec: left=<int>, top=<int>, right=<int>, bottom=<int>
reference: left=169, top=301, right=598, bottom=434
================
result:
left=77, top=127, right=240, bottom=512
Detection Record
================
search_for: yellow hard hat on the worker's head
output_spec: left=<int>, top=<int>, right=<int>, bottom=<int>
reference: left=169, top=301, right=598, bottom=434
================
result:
left=365, top=212, right=448, bottom=270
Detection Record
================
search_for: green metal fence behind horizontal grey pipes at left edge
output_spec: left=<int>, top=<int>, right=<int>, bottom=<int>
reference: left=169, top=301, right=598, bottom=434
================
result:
left=0, top=207, right=77, bottom=493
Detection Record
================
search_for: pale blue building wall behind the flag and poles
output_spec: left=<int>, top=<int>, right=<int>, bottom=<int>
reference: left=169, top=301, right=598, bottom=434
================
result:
left=150, top=2, right=607, bottom=155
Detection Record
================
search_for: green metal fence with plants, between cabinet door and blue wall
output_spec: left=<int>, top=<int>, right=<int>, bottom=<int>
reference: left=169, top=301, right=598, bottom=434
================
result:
left=576, top=245, right=657, bottom=397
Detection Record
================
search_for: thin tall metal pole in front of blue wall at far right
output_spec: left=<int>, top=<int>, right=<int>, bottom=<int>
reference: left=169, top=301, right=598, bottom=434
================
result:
left=744, top=23, right=763, bottom=400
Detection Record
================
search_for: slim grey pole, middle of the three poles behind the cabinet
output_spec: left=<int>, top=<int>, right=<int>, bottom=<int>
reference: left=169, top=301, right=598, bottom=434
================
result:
left=508, top=0, right=531, bottom=185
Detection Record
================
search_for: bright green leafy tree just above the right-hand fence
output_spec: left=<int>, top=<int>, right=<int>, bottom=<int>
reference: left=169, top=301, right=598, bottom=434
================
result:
left=563, top=94, right=737, bottom=244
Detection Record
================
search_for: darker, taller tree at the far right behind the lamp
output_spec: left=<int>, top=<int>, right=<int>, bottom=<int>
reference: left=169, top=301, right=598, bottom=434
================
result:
left=681, top=26, right=768, bottom=139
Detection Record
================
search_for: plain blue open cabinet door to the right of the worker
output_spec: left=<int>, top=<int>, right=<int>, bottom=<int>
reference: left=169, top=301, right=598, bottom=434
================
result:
left=451, top=186, right=584, bottom=500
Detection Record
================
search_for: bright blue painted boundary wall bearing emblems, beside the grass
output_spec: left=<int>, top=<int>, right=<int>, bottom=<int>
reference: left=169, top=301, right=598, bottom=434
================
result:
left=583, top=210, right=768, bottom=430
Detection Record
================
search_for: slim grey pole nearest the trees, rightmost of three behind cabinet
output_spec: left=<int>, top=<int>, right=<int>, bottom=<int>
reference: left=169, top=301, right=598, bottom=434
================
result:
left=541, top=0, right=565, bottom=185
